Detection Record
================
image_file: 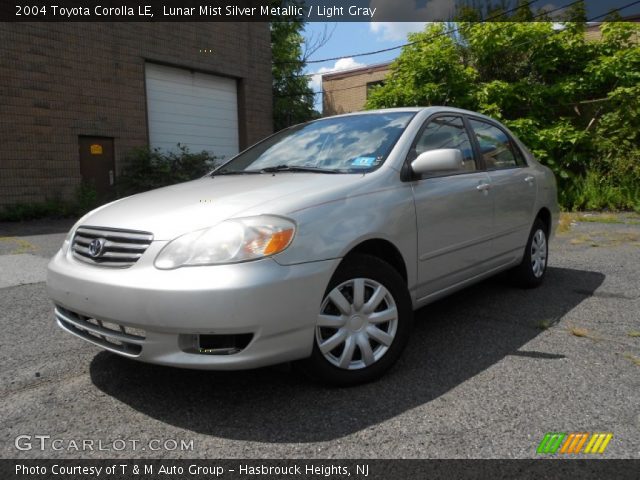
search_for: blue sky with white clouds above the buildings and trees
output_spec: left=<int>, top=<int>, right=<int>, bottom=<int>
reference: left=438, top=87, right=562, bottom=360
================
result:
left=304, top=0, right=639, bottom=111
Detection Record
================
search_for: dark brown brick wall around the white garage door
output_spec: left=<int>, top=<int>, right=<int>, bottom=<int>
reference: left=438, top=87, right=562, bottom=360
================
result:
left=0, top=23, right=272, bottom=206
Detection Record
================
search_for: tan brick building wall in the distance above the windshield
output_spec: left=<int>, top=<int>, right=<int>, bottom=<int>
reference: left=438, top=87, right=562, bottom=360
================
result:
left=322, top=64, right=389, bottom=116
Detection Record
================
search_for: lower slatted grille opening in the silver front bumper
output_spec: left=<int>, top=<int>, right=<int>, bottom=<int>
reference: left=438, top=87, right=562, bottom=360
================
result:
left=55, top=305, right=146, bottom=357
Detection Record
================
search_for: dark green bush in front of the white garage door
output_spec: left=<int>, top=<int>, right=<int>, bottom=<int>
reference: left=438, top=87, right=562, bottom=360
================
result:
left=116, top=144, right=219, bottom=196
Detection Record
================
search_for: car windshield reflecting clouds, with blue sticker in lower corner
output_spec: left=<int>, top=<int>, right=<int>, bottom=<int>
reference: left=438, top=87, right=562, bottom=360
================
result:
left=213, top=112, right=414, bottom=175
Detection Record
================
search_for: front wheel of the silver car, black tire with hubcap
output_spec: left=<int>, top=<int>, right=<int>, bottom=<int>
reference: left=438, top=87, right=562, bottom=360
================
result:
left=303, top=254, right=413, bottom=387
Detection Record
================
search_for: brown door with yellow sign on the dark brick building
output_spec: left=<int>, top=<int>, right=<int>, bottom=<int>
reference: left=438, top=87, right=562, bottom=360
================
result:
left=78, top=136, right=116, bottom=201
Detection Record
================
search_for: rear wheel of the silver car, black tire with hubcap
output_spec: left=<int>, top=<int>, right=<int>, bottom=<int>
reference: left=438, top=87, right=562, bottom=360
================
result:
left=511, top=218, right=549, bottom=288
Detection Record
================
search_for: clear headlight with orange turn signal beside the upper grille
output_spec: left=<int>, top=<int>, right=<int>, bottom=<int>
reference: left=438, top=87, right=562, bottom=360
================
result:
left=155, top=215, right=296, bottom=270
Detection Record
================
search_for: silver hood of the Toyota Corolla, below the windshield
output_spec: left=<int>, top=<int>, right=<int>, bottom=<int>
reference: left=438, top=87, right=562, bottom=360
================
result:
left=83, top=172, right=364, bottom=240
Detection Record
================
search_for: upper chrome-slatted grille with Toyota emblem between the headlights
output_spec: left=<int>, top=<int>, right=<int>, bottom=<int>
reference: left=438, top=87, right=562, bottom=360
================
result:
left=71, top=226, right=153, bottom=268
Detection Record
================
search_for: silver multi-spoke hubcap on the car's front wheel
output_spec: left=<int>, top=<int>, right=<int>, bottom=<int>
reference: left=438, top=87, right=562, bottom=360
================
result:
left=316, top=278, right=398, bottom=370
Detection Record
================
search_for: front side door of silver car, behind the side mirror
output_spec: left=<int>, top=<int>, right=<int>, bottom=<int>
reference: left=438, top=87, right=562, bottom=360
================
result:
left=407, top=114, right=493, bottom=300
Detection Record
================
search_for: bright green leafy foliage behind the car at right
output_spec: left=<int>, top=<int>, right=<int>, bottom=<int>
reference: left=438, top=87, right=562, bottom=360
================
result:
left=366, top=22, right=640, bottom=210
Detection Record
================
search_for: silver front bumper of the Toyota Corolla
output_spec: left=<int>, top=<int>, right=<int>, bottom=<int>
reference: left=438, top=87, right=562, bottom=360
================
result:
left=47, top=242, right=339, bottom=370
